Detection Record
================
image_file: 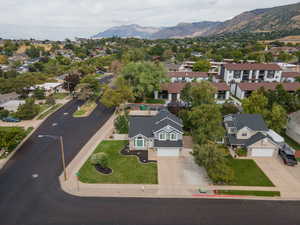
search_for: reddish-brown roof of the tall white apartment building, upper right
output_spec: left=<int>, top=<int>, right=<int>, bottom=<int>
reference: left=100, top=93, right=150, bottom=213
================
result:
left=225, top=63, right=281, bottom=71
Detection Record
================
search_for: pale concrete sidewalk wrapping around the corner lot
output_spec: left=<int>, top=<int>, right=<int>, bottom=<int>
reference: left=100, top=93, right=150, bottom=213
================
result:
left=59, top=112, right=300, bottom=200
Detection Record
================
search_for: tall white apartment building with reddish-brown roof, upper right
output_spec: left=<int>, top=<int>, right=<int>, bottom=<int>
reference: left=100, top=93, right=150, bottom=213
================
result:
left=221, top=63, right=282, bottom=84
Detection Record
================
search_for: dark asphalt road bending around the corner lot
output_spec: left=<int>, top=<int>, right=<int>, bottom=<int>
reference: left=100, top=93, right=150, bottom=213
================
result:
left=0, top=78, right=300, bottom=225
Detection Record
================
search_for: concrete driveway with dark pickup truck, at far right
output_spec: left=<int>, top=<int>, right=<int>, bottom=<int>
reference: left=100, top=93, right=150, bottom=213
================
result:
left=254, top=156, right=300, bottom=198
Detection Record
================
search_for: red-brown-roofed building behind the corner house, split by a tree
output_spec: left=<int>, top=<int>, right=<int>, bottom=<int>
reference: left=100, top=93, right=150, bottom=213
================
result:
left=154, top=82, right=230, bottom=104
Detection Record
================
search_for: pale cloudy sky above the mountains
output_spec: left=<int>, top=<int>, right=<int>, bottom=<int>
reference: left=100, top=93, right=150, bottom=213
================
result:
left=0, top=0, right=299, bottom=40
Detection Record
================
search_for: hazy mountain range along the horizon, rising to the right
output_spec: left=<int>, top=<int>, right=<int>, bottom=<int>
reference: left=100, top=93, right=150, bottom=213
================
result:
left=92, top=3, right=300, bottom=39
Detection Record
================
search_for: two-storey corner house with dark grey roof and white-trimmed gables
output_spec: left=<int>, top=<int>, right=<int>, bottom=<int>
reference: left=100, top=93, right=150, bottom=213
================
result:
left=129, top=110, right=183, bottom=156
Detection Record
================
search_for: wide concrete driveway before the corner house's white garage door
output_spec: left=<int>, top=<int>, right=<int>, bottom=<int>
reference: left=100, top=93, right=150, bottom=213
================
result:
left=157, top=149, right=210, bottom=187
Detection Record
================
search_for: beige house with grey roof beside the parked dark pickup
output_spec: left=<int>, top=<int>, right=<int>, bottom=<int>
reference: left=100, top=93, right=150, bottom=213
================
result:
left=224, top=114, right=279, bottom=157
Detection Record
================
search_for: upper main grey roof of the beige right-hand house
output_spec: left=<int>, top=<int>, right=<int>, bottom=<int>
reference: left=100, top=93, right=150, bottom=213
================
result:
left=227, top=113, right=268, bottom=131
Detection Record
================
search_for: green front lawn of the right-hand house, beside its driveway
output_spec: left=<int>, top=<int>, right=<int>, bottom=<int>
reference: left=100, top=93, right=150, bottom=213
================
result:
left=228, top=157, right=274, bottom=187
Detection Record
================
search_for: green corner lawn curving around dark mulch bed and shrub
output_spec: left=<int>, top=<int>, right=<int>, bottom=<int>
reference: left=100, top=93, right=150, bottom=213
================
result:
left=79, top=141, right=158, bottom=184
